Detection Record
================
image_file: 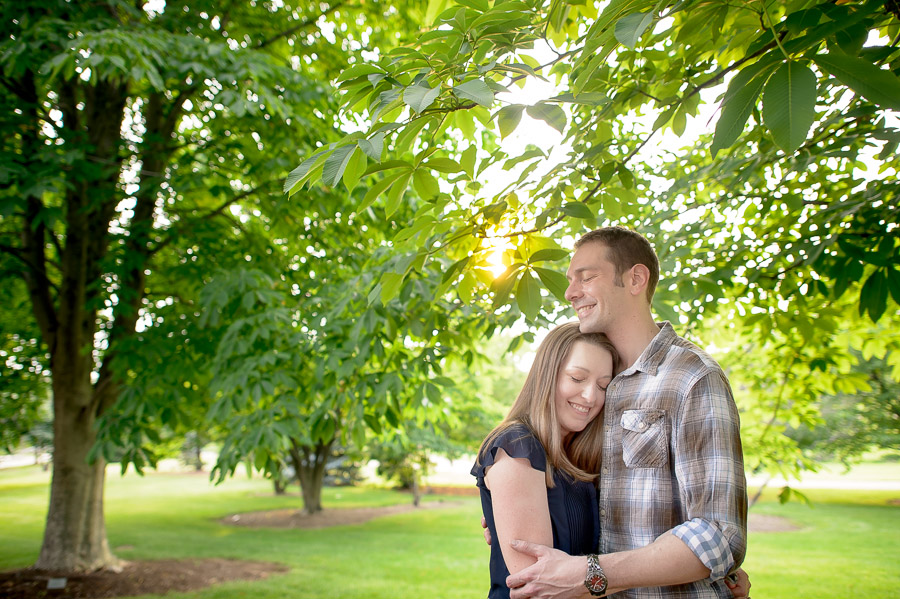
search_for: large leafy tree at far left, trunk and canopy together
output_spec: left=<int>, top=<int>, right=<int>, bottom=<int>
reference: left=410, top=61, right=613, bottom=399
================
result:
left=0, top=0, right=432, bottom=570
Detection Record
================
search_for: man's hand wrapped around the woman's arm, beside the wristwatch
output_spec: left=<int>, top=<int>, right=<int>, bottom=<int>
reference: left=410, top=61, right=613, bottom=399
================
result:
left=506, top=540, right=587, bottom=599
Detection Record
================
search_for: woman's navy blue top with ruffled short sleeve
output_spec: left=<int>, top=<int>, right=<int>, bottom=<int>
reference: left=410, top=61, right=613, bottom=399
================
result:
left=472, top=424, right=600, bottom=599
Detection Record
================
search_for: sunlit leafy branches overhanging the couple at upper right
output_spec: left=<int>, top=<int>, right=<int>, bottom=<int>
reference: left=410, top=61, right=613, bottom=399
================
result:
left=294, top=0, right=900, bottom=482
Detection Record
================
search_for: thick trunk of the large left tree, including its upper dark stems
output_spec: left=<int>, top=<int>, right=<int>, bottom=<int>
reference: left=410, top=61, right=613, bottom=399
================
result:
left=23, top=72, right=130, bottom=572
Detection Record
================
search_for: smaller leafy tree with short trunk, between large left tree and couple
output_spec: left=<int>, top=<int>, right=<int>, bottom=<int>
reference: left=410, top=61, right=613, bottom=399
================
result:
left=203, top=205, right=508, bottom=513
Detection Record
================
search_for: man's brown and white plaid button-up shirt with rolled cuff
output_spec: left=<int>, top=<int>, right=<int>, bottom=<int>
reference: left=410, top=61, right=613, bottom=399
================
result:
left=598, top=322, right=747, bottom=599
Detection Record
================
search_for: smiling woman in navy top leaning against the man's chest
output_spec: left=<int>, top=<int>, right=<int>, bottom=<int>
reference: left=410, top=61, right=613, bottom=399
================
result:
left=472, top=322, right=618, bottom=599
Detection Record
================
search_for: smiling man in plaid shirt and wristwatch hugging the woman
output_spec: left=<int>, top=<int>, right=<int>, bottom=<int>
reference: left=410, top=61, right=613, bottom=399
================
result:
left=507, top=227, right=749, bottom=599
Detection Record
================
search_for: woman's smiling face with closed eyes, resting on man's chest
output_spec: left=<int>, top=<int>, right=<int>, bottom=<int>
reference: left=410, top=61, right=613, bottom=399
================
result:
left=554, top=341, right=613, bottom=437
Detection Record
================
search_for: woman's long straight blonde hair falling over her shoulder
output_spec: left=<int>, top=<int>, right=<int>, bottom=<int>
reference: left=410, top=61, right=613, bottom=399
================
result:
left=478, top=322, right=619, bottom=488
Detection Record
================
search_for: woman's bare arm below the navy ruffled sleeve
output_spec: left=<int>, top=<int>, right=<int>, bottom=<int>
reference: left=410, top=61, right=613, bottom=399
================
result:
left=484, top=448, right=553, bottom=574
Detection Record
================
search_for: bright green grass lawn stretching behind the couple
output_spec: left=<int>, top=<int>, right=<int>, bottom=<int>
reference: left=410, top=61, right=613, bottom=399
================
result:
left=0, top=468, right=900, bottom=599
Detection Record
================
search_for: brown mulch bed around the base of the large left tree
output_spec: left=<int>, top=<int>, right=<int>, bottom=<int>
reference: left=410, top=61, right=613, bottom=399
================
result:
left=0, top=559, right=290, bottom=599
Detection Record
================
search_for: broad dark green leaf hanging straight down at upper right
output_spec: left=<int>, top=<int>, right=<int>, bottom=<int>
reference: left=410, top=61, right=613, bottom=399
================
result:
left=763, top=61, right=816, bottom=154
